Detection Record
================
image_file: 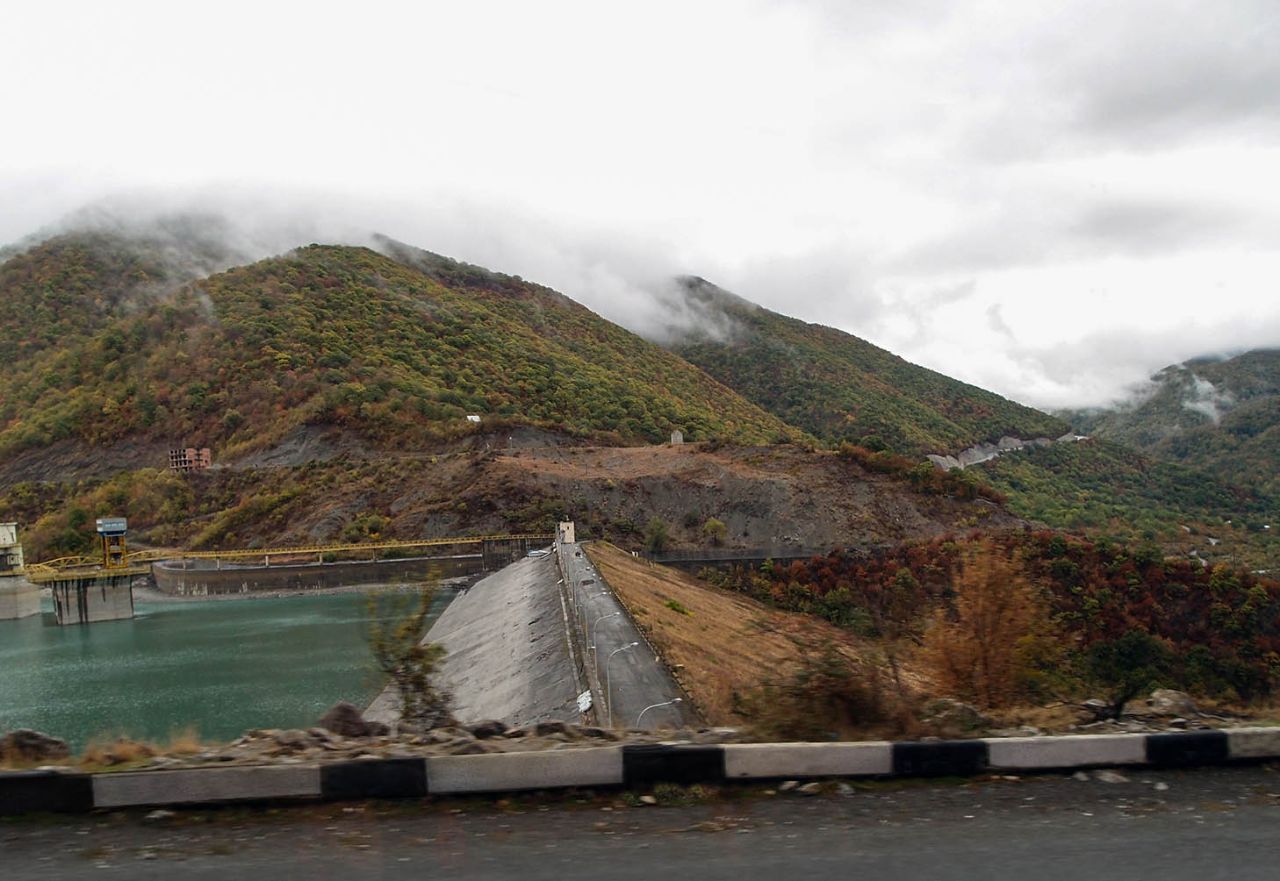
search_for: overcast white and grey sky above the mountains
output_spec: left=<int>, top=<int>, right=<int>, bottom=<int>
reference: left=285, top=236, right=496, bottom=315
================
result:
left=0, top=0, right=1280, bottom=407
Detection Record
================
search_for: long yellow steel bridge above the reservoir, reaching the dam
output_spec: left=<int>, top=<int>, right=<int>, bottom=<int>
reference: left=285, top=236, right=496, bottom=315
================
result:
left=26, top=533, right=554, bottom=584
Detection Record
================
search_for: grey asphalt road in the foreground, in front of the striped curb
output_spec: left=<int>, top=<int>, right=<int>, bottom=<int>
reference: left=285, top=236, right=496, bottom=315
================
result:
left=0, top=767, right=1280, bottom=881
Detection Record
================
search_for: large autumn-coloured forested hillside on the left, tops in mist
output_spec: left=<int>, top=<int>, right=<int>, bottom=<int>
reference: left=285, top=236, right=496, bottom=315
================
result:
left=0, top=237, right=800, bottom=457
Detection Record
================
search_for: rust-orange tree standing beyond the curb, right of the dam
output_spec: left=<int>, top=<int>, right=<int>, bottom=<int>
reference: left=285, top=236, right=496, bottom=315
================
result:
left=923, top=543, right=1048, bottom=707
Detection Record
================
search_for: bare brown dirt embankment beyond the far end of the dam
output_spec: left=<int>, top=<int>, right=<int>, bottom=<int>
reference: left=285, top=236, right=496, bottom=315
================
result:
left=493, top=446, right=1023, bottom=548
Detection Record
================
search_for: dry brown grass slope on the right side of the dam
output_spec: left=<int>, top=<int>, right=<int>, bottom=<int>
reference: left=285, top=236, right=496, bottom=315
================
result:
left=588, top=542, right=860, bottom=725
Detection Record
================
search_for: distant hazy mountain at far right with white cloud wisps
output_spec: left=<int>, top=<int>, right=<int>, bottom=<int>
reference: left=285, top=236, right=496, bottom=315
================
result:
left=1064, top=350, right=1280, bottom=494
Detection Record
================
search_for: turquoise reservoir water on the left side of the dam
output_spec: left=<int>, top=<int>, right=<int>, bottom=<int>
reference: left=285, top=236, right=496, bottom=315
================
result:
left=0, top=590, right=451, bottom=748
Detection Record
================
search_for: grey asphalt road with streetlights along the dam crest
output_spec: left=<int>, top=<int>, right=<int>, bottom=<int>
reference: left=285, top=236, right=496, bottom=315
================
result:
left=564, top=544, right=696, bottom=729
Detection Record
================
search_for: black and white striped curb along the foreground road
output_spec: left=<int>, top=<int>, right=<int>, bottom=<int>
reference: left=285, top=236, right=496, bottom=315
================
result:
left=0, top=727, right=1280, bottom=814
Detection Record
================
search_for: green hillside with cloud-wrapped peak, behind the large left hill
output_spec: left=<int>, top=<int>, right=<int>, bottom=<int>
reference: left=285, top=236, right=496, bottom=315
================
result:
left=671, top=278, right=1068, bottom=455
